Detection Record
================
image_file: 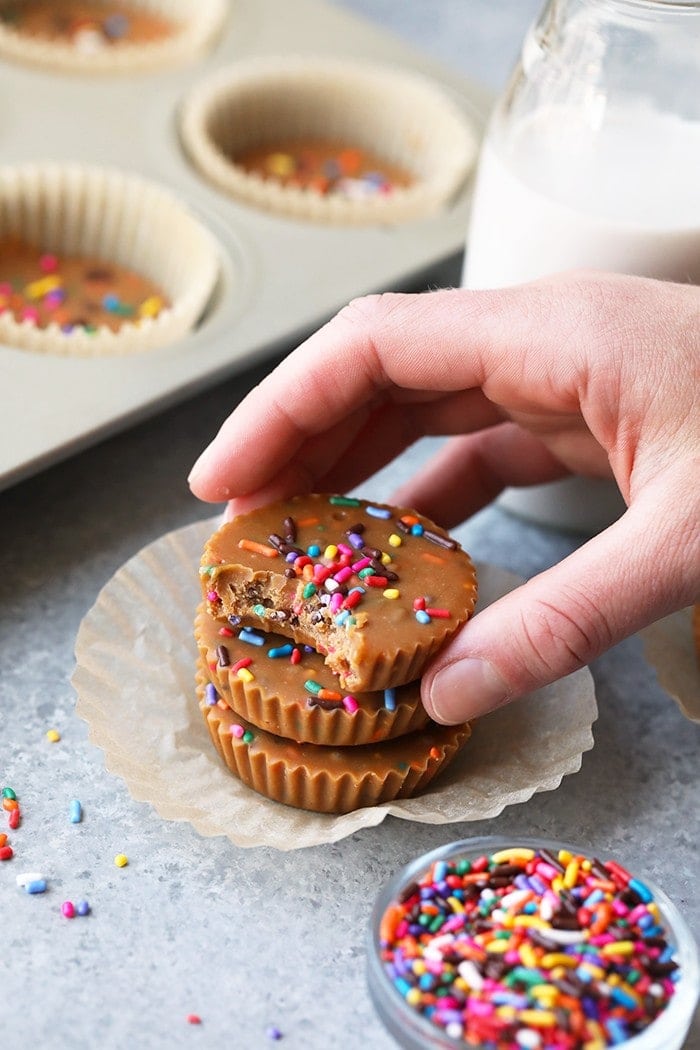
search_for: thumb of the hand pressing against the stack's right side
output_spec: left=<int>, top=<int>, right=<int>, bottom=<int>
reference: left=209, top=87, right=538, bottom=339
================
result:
left=422, top=492, right=700, bottom=725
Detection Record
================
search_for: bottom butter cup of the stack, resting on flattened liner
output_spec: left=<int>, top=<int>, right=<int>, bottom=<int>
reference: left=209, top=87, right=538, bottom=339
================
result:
left=197, top=659, right=470, bottom=814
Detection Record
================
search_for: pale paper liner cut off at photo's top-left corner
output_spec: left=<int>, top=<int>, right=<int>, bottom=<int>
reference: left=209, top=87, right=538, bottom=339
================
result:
left=0, top=0, right=227, bottom=74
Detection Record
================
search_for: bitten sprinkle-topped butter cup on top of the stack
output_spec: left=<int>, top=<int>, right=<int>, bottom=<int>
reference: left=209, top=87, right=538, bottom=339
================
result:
left=199, top=494, right=476, bottom=692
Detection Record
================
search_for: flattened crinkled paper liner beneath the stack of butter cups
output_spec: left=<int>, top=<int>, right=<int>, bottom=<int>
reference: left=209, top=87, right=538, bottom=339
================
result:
left=72, top=519, right=597, bottom=851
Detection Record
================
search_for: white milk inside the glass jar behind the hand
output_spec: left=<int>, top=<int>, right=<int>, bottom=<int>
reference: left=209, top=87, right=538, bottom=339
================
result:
left=463, top=104, right=700, bottom=531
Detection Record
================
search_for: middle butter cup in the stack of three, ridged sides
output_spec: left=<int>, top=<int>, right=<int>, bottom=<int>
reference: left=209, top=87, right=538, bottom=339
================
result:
left=195, top=603, right=428, bottom=748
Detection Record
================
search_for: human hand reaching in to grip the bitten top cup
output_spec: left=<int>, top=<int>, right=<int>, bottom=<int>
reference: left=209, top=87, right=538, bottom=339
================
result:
left=190, top=273, right=700, bottom=722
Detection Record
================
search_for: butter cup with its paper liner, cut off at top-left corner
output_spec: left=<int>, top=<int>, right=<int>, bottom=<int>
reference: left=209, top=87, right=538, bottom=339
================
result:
left=0, top=0, right=228, bottom=74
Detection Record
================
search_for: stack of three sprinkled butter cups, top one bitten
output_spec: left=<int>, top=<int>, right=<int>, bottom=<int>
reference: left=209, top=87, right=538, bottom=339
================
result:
left=195, top=494, right=476, bottom=814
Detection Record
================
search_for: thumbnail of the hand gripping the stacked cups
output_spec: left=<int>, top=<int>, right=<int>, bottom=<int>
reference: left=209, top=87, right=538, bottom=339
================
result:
left=429, top=657, right=510, bottom=726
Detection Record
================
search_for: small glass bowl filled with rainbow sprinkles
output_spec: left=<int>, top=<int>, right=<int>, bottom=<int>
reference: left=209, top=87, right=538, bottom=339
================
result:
left=367, top=837, right=700, bottom=1050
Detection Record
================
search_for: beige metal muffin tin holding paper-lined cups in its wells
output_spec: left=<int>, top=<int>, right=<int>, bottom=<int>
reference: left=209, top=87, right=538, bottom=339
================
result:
left=0, top=0, right=491, bottom=487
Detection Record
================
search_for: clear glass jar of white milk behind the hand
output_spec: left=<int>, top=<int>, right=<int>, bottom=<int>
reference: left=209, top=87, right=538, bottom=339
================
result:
left=463, top=0, right=700, bottom=531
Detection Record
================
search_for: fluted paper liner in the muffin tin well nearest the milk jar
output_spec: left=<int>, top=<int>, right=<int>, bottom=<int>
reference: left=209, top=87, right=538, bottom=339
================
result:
left=181, top=56, right=478, bottom=225
